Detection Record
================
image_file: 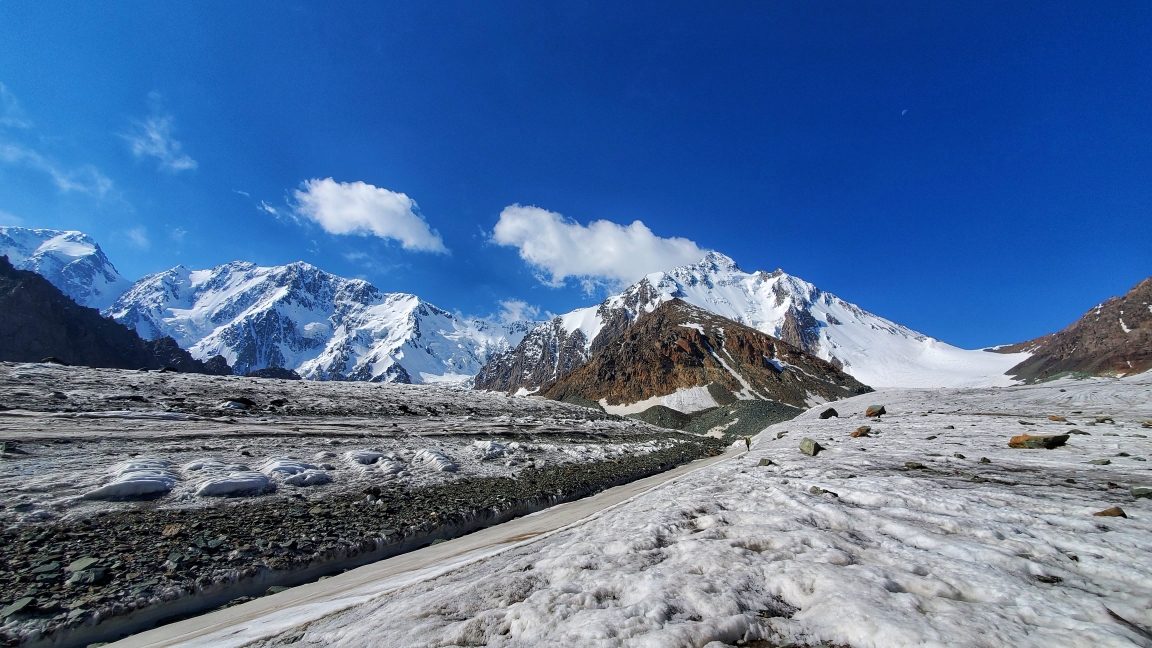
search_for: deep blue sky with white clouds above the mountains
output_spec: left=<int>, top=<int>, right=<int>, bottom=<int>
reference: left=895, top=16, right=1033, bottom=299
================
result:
left=0, top=0, right=1152, bottom=347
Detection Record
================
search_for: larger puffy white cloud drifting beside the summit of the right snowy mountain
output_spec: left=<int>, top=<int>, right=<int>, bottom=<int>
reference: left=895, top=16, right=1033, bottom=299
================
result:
left=492, top=205, right=705, bottom=292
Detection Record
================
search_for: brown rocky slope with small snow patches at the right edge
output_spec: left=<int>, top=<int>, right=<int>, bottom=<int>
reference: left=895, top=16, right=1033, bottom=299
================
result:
left=1008, top=278, right=1152, bottom=380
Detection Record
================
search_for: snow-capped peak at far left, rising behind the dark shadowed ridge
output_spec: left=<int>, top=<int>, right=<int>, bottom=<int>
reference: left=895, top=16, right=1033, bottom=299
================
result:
left=0, top=227, right=131, bottom=309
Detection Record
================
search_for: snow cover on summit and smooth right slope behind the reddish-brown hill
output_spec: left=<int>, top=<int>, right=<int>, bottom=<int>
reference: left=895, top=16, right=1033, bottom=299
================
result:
left=527, top=253, right=1030, bottom=389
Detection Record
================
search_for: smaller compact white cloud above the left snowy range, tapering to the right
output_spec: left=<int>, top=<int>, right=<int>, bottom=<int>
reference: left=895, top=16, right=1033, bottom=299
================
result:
left=294, top=178, right=448, bottom=253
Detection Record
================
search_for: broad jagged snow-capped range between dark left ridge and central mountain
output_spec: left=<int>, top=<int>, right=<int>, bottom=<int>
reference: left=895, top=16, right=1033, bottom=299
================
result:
left=107, top=261, right=533, bottom=383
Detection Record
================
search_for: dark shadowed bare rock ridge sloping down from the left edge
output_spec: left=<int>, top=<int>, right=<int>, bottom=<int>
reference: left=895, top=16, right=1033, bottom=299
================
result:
left=0, top=256, right=232, bottom=374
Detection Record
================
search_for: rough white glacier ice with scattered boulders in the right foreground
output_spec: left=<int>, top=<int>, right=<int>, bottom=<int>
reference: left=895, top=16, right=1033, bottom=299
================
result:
left=252, top=375, right=1152, bottom=648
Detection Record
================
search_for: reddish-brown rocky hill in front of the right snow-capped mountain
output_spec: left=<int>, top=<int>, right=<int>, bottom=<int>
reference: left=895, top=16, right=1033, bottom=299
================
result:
left=541, top=299, right=871, bottom=407
